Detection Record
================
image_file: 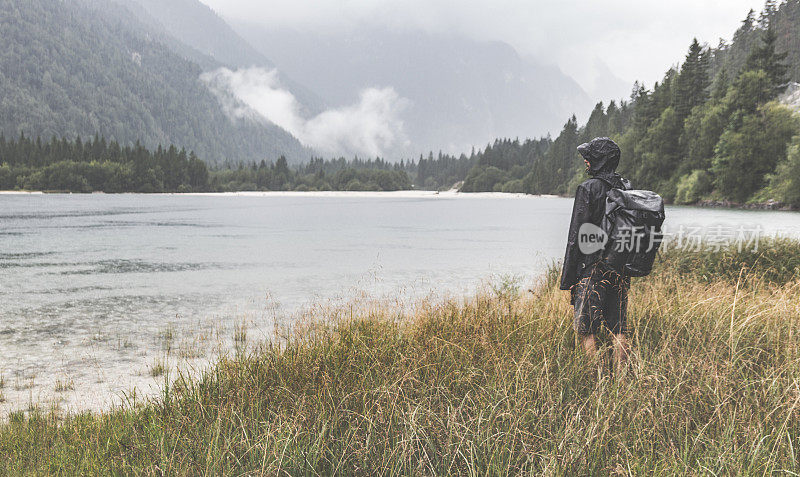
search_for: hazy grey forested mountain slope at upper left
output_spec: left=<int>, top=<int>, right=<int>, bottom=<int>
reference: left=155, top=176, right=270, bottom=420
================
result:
left=0, top=0, right=310, bottom=162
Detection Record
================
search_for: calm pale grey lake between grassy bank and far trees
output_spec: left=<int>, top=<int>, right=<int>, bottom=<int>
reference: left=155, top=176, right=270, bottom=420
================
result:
left=0, top=192, right=800, bottom=414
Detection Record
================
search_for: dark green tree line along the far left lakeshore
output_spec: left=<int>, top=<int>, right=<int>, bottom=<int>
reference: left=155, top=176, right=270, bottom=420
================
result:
left=0, top=134, right=411, bottom=192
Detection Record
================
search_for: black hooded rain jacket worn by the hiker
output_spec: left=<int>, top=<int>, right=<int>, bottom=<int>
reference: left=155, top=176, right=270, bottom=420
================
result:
left=561, top=138, right=631, bottom=290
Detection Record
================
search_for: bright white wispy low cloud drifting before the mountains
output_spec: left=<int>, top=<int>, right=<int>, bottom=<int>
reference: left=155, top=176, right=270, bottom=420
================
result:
left=200, top=68, right=408, bottom=157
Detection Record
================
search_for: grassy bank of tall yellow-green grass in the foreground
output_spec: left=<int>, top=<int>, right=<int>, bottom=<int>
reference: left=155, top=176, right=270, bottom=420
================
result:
left=0, top=242, right=800, bottom=475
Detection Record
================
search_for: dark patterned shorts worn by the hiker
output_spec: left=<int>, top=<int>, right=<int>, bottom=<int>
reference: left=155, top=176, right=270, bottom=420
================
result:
left=572, top=262, right=630, bottom=335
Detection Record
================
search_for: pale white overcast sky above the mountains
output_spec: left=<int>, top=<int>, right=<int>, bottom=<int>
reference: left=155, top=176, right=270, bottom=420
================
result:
left=202, top=0, right=763, bottom=99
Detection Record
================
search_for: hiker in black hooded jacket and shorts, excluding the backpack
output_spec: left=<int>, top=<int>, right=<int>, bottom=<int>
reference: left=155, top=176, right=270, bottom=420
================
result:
left=561, top=137, right=631, bottom=369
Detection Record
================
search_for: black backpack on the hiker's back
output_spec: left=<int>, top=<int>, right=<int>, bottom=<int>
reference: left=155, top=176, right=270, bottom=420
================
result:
left=601, top=187, right=665, bottom=277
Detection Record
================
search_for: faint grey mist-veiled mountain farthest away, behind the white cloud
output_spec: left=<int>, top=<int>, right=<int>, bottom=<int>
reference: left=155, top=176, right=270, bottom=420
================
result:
left=233, top=23, right=591, bottom=154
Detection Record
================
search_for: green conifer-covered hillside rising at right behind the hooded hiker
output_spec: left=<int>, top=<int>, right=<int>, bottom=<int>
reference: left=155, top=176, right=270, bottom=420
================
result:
left=462, top=0, right=800, bottom=206
